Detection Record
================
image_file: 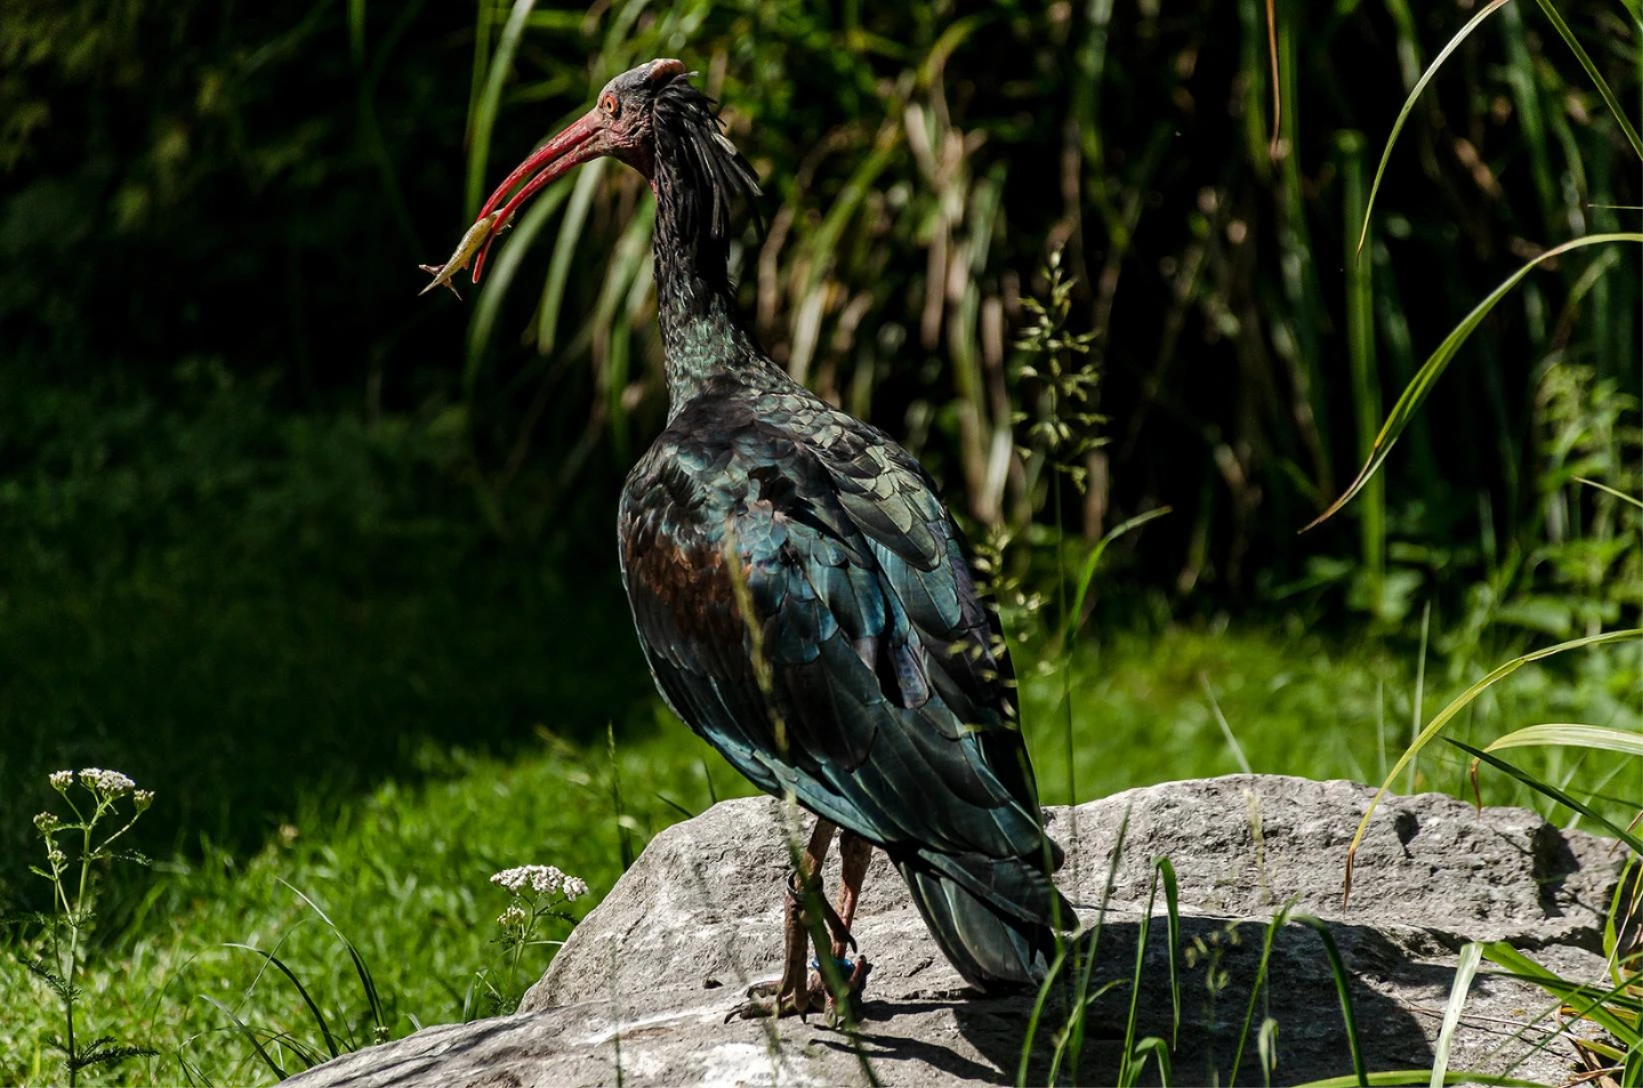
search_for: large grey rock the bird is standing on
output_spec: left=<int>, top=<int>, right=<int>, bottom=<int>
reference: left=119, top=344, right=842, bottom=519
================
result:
left=286, top=776, right=1618, bottom=1088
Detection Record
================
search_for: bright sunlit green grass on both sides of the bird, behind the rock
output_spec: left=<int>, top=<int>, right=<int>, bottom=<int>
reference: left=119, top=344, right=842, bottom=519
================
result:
left=0, top=626, right=1638, bottom=1088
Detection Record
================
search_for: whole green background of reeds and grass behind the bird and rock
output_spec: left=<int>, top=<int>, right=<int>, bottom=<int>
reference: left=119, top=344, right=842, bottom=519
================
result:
left=0, top=0, right=1643, bottom=1083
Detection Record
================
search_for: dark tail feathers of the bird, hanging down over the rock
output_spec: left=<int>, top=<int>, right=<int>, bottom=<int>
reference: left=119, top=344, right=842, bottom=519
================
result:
left=895, top=851, right=1078, bottom=989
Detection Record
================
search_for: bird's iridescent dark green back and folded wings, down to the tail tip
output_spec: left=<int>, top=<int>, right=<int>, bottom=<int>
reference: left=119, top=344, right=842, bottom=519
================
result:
left=619, top=375, right=1073, bottom=984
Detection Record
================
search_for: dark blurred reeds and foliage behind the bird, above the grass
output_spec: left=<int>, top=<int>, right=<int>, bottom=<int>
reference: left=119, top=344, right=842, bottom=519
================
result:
left=12, top=0, right=1643, bottom=604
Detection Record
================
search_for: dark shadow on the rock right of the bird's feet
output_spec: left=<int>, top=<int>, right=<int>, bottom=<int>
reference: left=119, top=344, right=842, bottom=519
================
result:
left=817, top=917, right=1454, bottom=1085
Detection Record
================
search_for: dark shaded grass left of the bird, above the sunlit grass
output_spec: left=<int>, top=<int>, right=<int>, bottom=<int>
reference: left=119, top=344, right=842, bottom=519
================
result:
left=0, top=367, right=649, bottom=904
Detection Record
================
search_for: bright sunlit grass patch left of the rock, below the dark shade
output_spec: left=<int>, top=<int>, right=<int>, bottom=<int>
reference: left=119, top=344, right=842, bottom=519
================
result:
left=0, top=719, right=732, bottom=1085
